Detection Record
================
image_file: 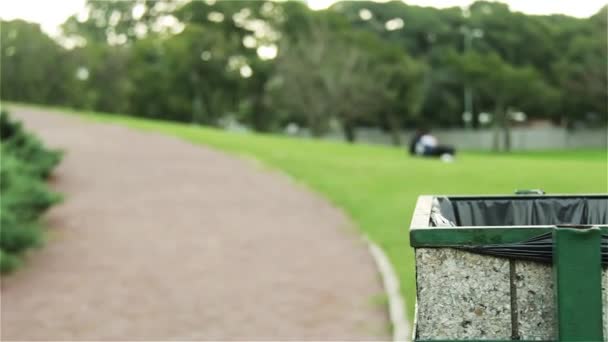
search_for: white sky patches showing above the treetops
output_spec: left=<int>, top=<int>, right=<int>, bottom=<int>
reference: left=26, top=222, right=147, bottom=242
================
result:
left=0, top=0, right=608, bottom=34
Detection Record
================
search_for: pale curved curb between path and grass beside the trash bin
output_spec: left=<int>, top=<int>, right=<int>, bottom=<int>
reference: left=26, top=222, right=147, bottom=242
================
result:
left=365, top=236, right=412, bottom=342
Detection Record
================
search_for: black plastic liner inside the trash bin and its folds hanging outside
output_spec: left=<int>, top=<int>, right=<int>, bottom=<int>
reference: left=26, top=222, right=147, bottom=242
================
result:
left=430, top=196, right=608, bottom=266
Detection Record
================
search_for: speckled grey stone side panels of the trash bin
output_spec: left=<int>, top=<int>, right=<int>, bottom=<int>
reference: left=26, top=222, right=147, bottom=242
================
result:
left=415, top=248, right=608, bottom=341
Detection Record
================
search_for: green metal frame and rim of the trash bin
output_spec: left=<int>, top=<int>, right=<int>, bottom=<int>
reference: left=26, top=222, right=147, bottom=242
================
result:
left=410, top=194, right=608, bottom=342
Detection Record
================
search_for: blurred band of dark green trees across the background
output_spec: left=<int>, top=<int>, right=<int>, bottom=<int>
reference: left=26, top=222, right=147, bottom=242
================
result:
left=1, top=0, right=608, bottom=143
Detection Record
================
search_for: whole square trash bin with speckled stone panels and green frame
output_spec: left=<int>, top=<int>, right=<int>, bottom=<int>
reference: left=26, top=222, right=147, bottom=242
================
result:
left=410, top=191, right=608, bottom=341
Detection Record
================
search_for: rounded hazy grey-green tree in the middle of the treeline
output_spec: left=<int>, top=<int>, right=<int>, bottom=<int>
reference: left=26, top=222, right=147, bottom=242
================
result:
left=271, top=12, right=420, bottom=142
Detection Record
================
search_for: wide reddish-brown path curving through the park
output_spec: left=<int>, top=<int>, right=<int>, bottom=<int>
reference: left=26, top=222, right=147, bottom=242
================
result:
left=1, top=109, right=389, bottom=341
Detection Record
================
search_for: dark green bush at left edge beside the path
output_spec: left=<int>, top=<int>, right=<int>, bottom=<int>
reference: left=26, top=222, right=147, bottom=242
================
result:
left=0, top=112, right=61, bottom=273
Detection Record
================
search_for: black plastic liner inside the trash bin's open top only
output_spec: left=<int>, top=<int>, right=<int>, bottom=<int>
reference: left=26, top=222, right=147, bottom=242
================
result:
left=431, top=196, right=608, bottom=227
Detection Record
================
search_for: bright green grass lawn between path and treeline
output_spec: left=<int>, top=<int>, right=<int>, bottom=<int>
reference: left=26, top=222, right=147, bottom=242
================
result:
left=5, top=103, right=608, bottom=318
